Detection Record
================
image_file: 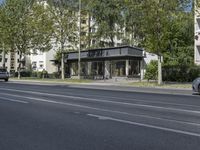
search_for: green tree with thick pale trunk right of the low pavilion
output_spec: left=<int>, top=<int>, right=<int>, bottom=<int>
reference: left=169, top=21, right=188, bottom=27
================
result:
left=143, top=0, right=189, bottom=85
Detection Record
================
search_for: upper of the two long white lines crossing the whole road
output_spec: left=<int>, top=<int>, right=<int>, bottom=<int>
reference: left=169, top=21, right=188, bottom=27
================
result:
left=0, top=88, right=200, bottom=114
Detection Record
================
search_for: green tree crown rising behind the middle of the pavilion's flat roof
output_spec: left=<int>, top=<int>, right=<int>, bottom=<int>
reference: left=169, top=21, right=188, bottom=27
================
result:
left=88, top=0, right=123, bottom=47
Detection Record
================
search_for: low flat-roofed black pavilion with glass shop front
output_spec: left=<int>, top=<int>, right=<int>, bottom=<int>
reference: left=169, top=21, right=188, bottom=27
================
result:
left=65, top=46, right=144, bottom=79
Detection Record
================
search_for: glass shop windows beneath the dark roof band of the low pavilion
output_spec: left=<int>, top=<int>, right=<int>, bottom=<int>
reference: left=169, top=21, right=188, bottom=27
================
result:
left=70, top=60, right=140, bottom=78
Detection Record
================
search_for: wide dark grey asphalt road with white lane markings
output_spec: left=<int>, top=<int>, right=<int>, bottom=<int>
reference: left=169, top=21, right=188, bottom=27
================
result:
left=0, top=82, right=200, bottom=150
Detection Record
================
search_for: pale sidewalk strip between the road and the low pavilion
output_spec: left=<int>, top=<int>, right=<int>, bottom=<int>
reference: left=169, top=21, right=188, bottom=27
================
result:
left=10, top=79, right=193, bottom=95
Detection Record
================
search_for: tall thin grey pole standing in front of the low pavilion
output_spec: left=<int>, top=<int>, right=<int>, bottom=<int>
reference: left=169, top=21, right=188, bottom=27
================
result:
left=78, top=0, right=81, bottom=79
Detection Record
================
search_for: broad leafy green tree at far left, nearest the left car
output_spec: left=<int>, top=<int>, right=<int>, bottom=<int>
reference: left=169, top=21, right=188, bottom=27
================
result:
left=0, top=0, right=53, bottom=78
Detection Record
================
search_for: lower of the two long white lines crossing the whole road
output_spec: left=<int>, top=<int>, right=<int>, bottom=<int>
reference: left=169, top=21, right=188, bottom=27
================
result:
left=1, top=93, right=200, bottom=127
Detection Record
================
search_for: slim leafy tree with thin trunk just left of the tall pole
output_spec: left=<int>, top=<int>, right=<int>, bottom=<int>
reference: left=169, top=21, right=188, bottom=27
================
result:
left=48, top=0, right=78, bottom=79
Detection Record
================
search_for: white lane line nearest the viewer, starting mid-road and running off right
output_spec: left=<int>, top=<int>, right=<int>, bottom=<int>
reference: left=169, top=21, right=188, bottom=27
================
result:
left=87, top=114, right=200, bottom=137
